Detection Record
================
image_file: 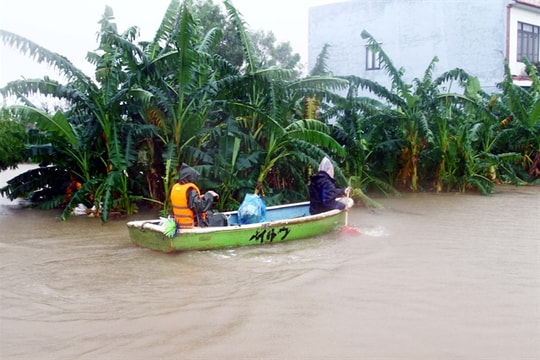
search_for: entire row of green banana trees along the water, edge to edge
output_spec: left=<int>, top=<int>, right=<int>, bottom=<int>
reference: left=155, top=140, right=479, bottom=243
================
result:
left=0, top=0, right=540, bottom=222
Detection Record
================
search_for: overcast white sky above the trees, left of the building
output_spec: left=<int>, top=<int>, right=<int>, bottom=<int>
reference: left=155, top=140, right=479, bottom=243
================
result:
left=0, top=0, right=344, bottom=87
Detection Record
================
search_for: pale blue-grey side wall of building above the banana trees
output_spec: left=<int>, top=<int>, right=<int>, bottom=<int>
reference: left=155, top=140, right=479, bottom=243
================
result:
left=308, top=0, right=509, bottom=91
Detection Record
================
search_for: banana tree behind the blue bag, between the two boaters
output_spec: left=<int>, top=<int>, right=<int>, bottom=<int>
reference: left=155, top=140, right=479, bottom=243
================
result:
left=220, top=1, right=346, bottom=201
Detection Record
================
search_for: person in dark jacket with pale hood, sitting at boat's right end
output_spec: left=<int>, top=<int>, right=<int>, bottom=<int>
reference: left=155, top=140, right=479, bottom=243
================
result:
left=309, top=156, right=353, bottom=215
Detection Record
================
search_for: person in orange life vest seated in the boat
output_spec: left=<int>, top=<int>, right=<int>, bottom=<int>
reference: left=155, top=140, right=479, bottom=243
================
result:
left=170, top=163, right=219, bottom=229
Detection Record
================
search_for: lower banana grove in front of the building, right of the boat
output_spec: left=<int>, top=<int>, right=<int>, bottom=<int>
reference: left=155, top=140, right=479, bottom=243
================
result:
left=316, top=31, right=540, bottom=194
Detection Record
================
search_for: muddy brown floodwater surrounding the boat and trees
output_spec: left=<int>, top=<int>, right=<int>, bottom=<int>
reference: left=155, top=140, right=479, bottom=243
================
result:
left=0, top=167, right=540, bottom=360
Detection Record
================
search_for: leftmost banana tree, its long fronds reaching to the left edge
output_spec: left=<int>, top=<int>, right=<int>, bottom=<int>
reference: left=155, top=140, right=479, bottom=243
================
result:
left=0, top=7, right=148, bottom=221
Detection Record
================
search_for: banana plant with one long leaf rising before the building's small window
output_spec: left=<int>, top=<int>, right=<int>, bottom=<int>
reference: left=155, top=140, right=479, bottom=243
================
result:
left=359, top=31, right=510, bottom=191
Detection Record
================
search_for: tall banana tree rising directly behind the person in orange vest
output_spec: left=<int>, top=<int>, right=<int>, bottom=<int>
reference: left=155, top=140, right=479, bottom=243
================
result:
left=126, top=0, right=230, bottom=212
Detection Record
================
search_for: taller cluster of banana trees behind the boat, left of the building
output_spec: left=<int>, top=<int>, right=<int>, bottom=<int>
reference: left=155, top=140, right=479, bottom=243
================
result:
left=1, top=0, right=342, bottom=221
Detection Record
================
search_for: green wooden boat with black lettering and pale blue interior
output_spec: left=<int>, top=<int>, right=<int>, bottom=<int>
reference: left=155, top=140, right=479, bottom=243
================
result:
left=127, top=202, right=346, bottom=253
